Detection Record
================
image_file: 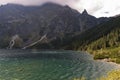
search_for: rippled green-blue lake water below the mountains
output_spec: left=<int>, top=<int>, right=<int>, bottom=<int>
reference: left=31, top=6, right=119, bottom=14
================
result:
left=0, top=50, right=118, bottom=80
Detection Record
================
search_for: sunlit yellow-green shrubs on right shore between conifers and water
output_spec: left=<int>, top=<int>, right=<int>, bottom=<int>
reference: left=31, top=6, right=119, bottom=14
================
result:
left=88, top=47, right=120, bottom=64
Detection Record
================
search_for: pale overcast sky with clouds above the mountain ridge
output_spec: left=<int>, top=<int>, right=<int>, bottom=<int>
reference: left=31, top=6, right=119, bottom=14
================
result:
left=0, top=0, right=120, bottom=17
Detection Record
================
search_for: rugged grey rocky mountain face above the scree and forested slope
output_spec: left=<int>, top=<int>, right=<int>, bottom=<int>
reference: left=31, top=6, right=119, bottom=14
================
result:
left=0, top=3, right=109, bottom=48
